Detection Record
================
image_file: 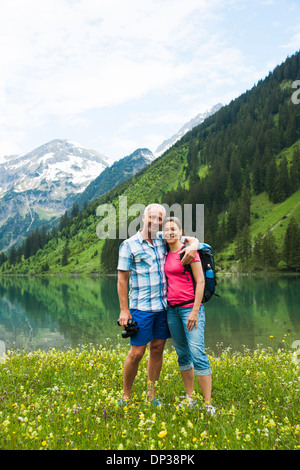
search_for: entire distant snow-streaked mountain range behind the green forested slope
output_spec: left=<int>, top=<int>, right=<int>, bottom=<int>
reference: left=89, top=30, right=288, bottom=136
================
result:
left=0, top=105, right=221, bottom=251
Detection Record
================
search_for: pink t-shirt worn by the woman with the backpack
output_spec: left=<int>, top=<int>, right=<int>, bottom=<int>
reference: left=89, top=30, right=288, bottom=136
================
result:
left=165, top=248, right=200, bottom=308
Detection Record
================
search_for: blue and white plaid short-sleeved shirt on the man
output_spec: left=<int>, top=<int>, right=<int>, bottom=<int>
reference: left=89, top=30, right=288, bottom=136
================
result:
left=117, top=231, right=167, bottom=312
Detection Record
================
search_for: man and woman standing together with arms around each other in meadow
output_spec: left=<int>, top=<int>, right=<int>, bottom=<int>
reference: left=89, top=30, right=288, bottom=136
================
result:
left=117, top=204, right=215, bottom=414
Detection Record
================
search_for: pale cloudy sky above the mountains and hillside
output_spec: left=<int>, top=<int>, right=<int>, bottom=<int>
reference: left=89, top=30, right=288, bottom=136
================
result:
left=0, top=0, right=300, bottom=161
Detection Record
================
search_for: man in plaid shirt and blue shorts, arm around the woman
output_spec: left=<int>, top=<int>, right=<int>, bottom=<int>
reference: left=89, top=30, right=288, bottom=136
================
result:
left=117, top=204, right=199, bottom=404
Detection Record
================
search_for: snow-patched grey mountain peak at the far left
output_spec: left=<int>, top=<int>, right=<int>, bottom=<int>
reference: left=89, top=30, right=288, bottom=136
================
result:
left=0, top=140, right=110, bottom=250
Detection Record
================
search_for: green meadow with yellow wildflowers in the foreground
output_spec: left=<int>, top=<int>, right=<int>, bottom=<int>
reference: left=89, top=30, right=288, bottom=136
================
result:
left=0, top=343, right=300, bottom=450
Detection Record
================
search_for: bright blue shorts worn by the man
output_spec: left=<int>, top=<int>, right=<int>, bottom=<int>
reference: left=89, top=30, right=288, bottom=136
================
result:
left=130, top=308, right=171, bottom=346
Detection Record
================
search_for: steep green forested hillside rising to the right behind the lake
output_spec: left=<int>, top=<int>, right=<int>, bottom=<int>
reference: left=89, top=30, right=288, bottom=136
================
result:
left=0, top=53, right=300, bottom=274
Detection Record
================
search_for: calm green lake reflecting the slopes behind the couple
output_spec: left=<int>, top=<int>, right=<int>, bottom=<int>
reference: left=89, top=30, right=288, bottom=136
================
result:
left=0, top=275, right=300, bottom=353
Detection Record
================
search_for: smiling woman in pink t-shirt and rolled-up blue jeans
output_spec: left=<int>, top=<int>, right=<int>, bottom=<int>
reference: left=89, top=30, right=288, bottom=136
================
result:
left=163, top=217, right=215, bottom=415
